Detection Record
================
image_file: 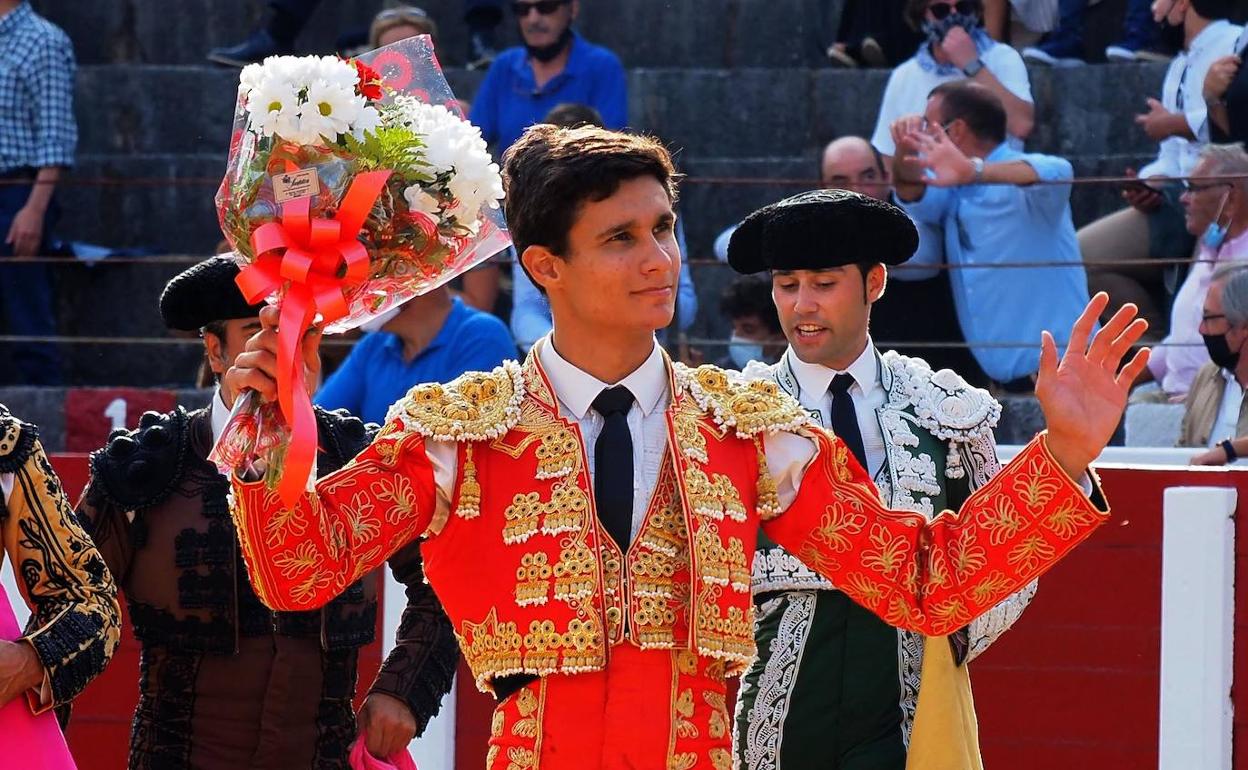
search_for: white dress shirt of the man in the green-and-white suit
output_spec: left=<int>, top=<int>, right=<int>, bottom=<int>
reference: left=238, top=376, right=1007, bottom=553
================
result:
left=785, top=337, right=889, bottom=478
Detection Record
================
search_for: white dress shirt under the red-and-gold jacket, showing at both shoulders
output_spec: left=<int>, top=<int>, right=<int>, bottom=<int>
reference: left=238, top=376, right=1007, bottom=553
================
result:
left=424, top=334, right=816, bottom=539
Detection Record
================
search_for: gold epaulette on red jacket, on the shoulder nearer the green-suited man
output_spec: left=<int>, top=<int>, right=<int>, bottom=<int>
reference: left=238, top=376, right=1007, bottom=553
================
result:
left=671, top=363, right=814, bottom=437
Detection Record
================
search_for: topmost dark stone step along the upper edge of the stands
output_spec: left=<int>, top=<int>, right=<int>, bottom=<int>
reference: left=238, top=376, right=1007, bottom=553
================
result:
left=35, top=0, right=842, bottom=67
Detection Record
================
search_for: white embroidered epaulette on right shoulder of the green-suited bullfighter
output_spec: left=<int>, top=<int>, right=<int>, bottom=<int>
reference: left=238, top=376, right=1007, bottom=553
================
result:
left=882, top=351, right=1001, bottom=442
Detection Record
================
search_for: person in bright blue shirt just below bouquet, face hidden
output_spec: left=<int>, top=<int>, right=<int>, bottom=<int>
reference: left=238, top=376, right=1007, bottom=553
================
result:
left=313, top=287, right=515, bottom=423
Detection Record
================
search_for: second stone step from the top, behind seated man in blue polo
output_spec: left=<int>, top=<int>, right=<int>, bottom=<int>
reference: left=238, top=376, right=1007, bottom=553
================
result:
left=76, top=64, right=1164, bottom=157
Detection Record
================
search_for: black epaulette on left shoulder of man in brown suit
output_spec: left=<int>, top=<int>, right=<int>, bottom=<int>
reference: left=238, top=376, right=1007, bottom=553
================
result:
left=91, top=407, right=191, bottom=510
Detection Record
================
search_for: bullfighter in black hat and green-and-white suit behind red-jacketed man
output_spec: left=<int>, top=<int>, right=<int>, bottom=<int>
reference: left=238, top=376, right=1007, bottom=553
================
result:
left=729, top=190, right=1036, bottom=770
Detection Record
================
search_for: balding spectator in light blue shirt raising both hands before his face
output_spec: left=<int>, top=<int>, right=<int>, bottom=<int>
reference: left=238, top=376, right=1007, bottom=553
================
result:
left=892, top=82, right=1088, bottom=392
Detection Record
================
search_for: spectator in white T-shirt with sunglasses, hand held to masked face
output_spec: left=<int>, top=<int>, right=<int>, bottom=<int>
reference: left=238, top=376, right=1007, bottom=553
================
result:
left=871, top=0, right=1036, bottom=156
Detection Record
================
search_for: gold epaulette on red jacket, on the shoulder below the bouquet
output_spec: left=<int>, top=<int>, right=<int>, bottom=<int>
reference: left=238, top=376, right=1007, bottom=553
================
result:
left=386, top=361, right=524, bottom=441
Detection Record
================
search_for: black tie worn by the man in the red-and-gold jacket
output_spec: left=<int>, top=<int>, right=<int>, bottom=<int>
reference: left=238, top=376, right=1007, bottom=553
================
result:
left=593, top=386, right=633, bottom=552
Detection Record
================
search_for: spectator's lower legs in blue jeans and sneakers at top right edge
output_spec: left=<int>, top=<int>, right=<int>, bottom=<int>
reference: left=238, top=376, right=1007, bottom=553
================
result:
left=1022, top=0, right=1171, bottom=66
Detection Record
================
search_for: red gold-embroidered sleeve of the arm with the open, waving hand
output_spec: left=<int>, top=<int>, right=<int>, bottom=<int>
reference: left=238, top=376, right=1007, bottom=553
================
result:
left=764, top=433, right=1109, bottom=636
